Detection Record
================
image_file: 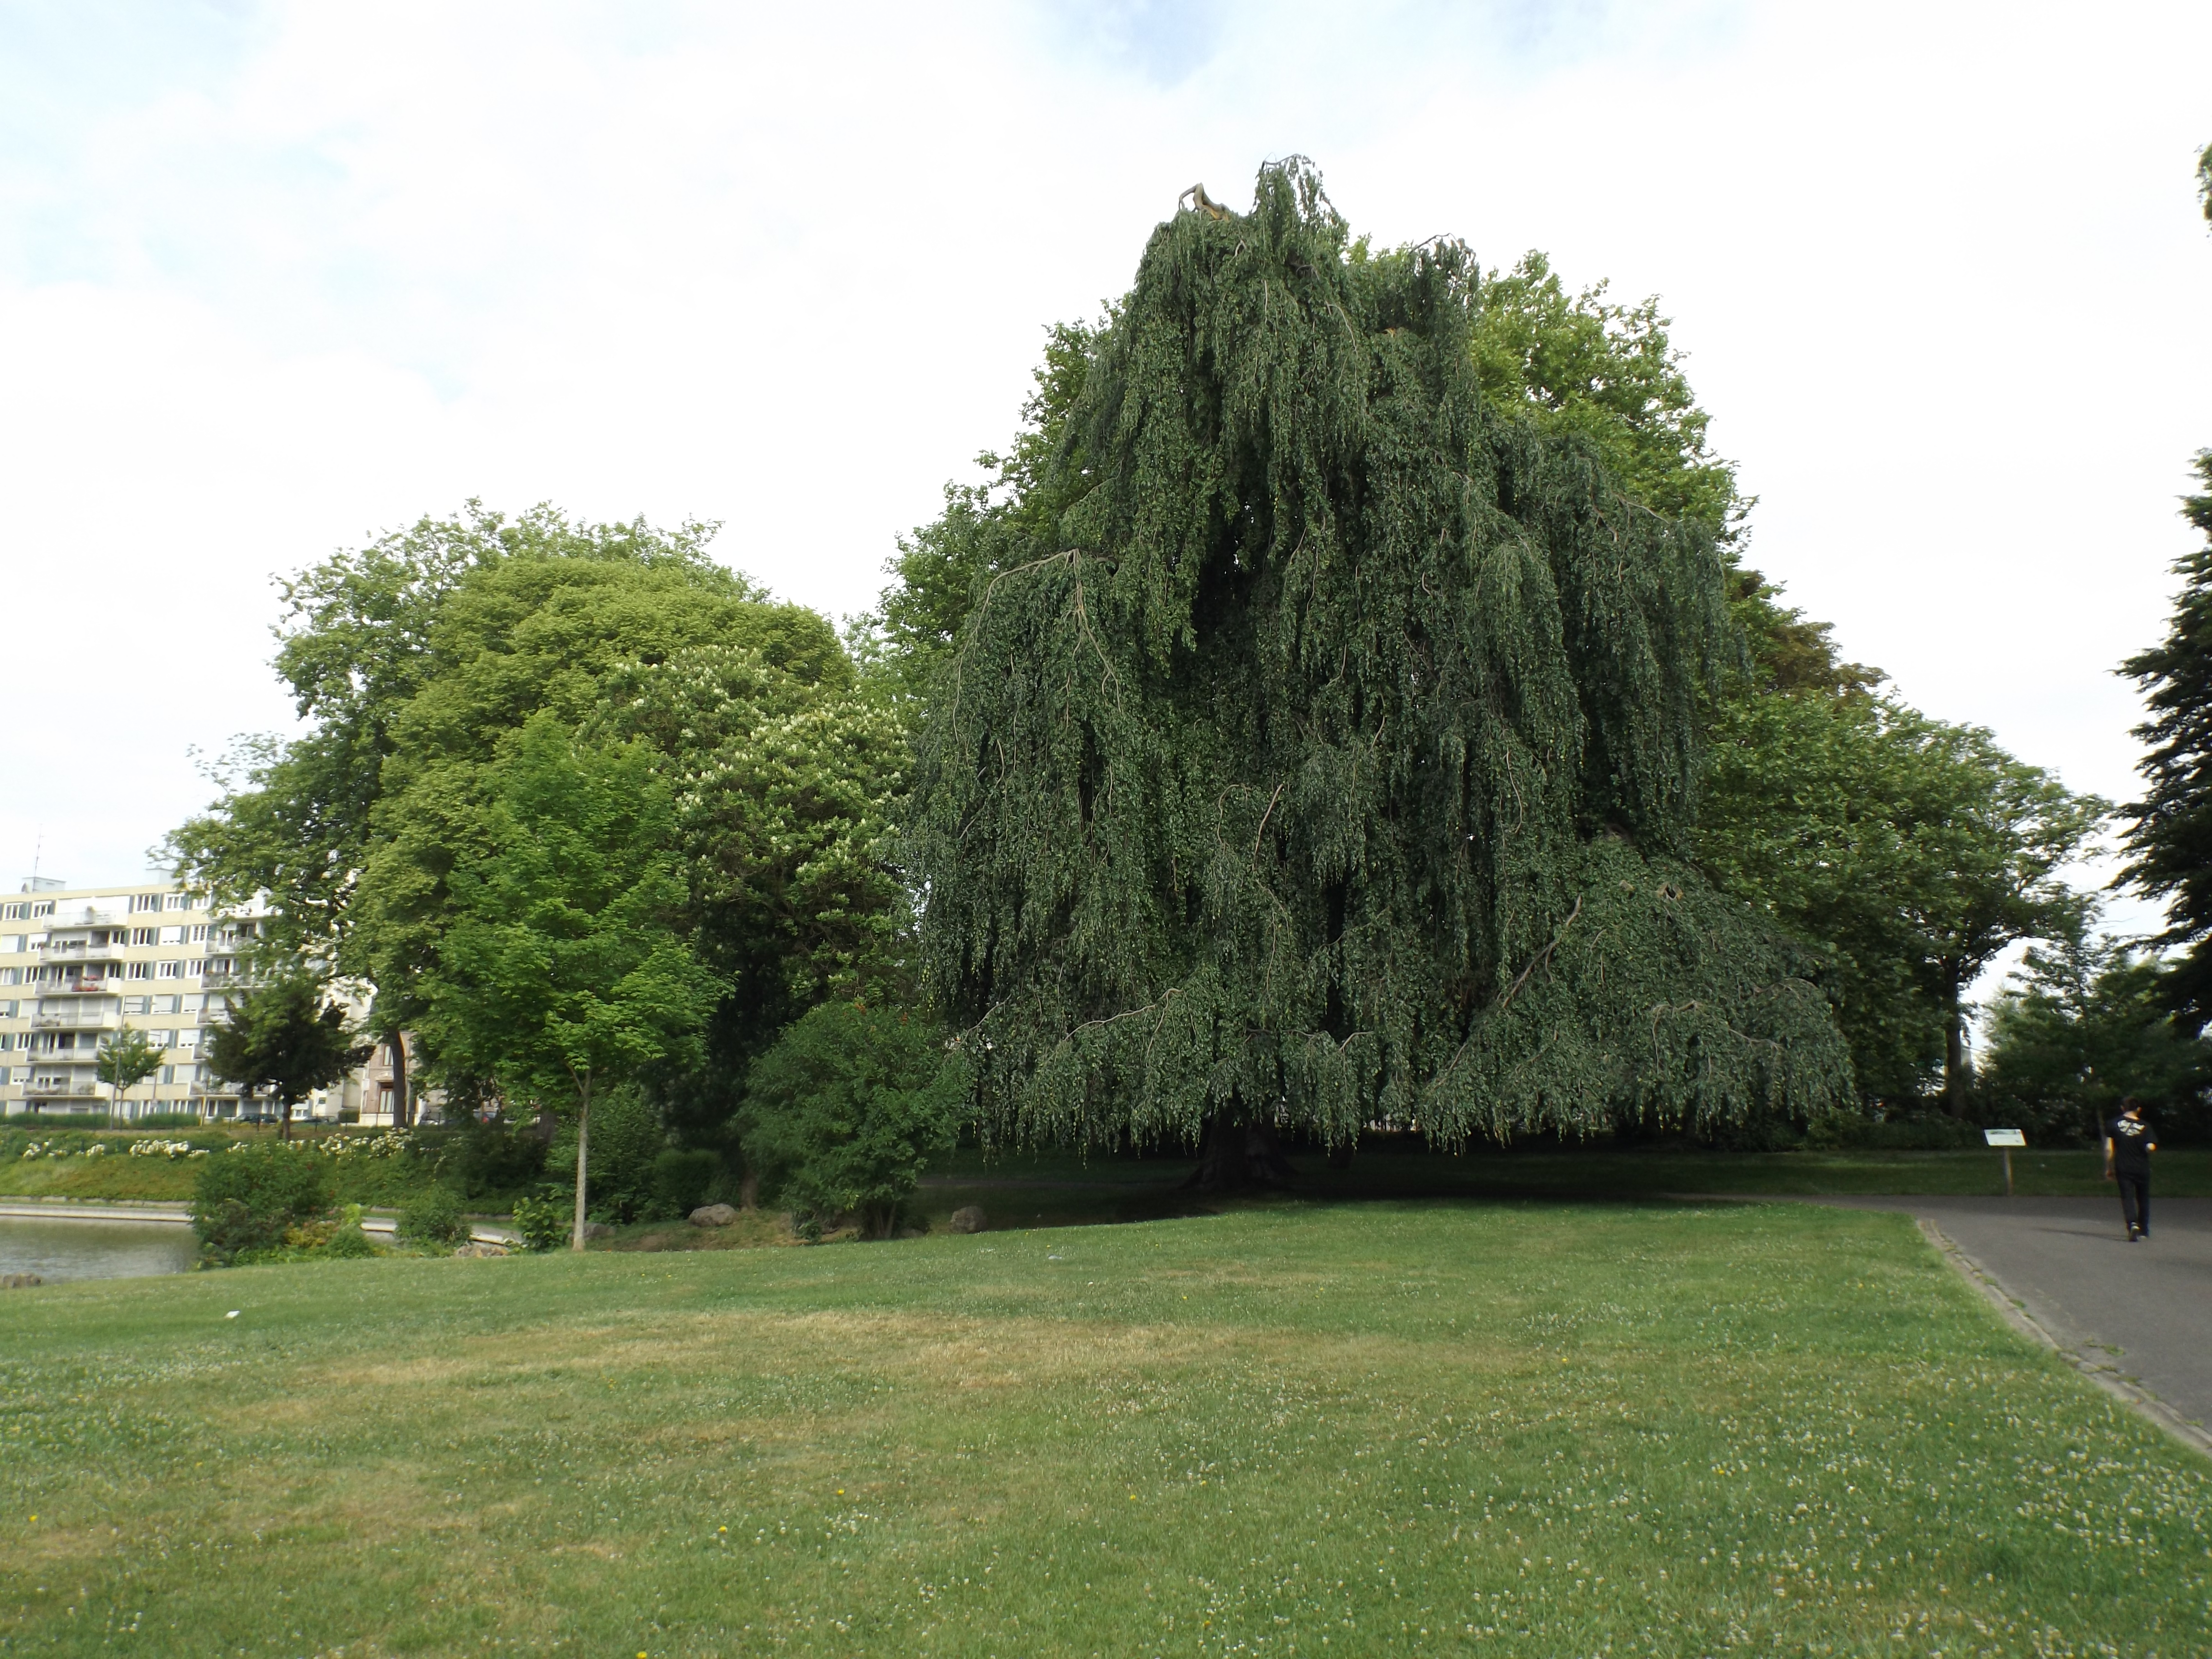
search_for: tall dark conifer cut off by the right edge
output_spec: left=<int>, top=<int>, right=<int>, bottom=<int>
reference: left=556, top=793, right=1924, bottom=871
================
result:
left=2121, top=451, right=2212, bottom=1033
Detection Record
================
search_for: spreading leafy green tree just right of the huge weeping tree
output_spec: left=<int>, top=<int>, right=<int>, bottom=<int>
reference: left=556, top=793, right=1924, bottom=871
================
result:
left=1696, top=695, right=2106, bottom=1102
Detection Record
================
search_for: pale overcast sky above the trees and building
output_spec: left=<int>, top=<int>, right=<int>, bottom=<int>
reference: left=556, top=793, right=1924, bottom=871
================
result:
left=0, top=0, right=2212, bottom=982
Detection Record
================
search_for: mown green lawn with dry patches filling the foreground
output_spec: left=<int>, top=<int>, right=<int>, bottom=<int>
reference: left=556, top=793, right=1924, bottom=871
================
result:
left=0, top=1201, right=2212, bottom=1659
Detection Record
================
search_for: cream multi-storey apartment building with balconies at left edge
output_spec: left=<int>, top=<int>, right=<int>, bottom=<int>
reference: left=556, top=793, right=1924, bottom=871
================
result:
left=0, top=878, right=363, bottom=1119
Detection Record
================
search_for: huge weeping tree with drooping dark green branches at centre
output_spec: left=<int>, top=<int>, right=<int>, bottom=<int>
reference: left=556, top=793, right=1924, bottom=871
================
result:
left=907, top=161, right=1851, bottom=1186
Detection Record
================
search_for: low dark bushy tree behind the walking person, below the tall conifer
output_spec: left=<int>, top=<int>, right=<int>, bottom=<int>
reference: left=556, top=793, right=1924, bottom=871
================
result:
left=1982, top=940, right=2212, bottom=1143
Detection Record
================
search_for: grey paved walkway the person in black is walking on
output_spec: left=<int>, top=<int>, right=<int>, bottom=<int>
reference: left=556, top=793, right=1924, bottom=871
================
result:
left=1769, top=1186, right=2212, bottom=1451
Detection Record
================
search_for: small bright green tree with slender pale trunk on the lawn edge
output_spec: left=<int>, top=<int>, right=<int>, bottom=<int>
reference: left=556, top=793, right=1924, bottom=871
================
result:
left=411, top=710, right=723, bottom=1250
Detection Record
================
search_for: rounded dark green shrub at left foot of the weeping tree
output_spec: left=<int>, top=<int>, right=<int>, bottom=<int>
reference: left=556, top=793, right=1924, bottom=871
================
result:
left=743, top=1002, right=969, bottom=1238
